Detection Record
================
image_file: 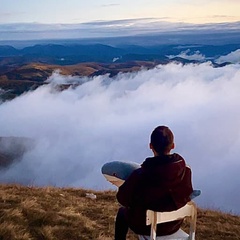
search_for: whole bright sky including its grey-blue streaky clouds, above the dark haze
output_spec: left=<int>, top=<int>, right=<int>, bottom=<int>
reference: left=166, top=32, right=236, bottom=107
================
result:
left=0, top=0, right=240, bottom=41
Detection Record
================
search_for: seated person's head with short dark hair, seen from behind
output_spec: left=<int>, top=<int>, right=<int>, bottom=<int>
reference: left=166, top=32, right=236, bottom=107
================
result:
left=150, top=126, right=174, bottom=155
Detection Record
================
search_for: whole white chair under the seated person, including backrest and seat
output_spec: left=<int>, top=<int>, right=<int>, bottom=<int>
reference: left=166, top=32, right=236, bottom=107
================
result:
left=139, top=201, right=197, bottom=240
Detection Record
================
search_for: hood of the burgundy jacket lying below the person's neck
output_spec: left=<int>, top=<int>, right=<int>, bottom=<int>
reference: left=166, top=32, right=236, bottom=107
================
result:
left=142, top=153, right=186, bottom=186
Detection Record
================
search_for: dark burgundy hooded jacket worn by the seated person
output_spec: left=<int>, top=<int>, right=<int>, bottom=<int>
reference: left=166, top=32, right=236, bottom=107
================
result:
left=117, top=153, right=193, bottom=236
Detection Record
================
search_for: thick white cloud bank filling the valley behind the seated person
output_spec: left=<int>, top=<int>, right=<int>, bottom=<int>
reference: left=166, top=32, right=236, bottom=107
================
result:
left=0, top=63, right=240, bottom=214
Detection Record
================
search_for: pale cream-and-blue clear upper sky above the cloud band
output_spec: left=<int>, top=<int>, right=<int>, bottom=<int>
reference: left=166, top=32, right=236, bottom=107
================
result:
left=0, top=0, right=240, bottom=24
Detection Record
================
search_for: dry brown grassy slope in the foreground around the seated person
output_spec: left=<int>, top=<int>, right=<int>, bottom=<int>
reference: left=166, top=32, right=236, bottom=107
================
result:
left=0, top=185, right=240, bottom=240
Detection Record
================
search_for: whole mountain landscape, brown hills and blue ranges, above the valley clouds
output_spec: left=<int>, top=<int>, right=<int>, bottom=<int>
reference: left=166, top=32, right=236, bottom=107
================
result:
left=0, top=41, right=240, bottom=99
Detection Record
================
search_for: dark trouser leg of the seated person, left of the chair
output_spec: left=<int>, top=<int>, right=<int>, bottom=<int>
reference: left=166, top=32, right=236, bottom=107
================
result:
left=114, top=207, right=128, bottom=240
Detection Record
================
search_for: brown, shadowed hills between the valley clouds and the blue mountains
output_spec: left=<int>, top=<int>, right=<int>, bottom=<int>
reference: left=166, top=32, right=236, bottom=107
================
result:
left=0, top=61, right=159, bottom=100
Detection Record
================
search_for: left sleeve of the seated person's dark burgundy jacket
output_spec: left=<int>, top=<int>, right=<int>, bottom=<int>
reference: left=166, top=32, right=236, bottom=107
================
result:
left=117, top=168, right=141, bottom=207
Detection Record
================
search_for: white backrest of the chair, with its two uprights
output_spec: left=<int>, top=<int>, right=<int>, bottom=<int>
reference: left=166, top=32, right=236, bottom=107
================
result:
left=146, top=201, right=197, bottom=240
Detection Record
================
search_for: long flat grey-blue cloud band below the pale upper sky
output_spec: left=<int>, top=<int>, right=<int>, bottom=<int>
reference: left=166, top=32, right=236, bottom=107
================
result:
left=0, top=18, right=240, bottom=40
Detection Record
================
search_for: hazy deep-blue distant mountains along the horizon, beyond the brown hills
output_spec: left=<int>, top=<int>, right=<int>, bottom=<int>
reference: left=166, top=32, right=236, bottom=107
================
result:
left=0, top=43, right=240, bottom=65
